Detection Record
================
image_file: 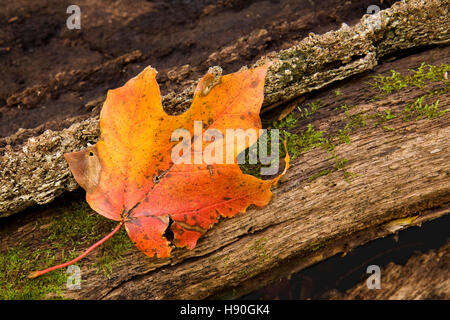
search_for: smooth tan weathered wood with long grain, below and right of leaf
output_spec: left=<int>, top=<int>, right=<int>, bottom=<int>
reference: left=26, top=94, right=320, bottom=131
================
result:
left=0, top=47, right=440, bottom=299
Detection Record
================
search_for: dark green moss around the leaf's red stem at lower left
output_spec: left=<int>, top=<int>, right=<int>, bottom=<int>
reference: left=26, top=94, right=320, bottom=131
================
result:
left=0, top=202, right=133, bottom=299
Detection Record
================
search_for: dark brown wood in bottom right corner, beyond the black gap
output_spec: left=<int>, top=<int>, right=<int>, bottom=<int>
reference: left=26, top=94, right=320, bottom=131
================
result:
left=329, top=242, right=450, bottom=300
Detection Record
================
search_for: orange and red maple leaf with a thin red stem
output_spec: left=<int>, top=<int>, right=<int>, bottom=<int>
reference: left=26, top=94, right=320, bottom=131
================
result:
left=30, top=65, right=288, bottom=277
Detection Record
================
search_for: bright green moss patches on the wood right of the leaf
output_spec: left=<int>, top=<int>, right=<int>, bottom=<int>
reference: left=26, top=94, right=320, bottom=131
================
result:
left=246, top=63, right=450, bottom=183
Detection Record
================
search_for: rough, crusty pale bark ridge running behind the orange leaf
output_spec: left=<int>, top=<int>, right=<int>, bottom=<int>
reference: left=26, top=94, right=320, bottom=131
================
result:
left=0, top=0, right=450, bottom=217
